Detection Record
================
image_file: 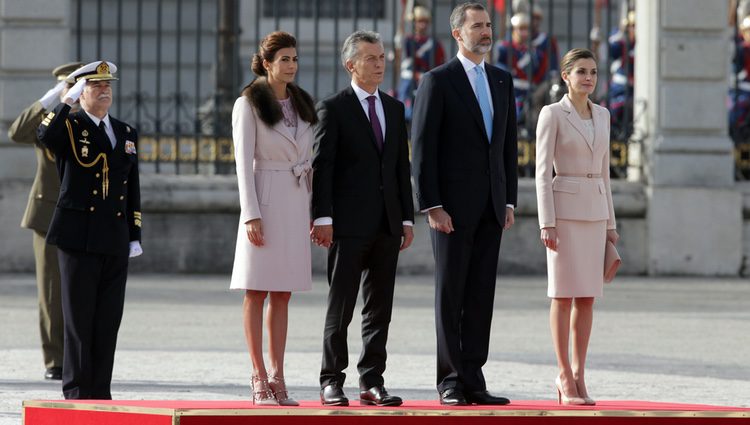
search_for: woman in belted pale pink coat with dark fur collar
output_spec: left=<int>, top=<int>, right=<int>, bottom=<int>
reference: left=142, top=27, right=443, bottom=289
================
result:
left=231, top=31, right=317, bottom=406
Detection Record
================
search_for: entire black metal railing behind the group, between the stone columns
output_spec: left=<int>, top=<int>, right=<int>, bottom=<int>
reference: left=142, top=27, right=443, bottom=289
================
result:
left=73, top=0, right=633, bottom=177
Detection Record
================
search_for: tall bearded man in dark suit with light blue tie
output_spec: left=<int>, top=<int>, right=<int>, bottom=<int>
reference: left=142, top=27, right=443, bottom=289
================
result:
left=412, top=3, right=518, bottom=405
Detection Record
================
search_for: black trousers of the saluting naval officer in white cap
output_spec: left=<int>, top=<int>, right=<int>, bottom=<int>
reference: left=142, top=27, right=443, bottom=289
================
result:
left=58, top=249, right=128, bottom=399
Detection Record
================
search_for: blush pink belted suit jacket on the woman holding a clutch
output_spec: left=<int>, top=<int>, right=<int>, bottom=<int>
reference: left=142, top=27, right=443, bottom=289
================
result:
left=536, top=95, right=616, bottom=229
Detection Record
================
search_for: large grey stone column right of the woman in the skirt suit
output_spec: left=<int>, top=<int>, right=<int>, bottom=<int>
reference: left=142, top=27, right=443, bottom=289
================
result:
left=636, top=0, right=742, bottom=276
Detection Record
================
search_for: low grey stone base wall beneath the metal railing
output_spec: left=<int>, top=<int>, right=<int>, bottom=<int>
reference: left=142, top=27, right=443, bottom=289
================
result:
left=0, top=174, right=646, bottom=274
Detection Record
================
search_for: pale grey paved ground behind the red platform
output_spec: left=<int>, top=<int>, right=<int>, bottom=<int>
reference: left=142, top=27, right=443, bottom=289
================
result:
left=0, top=275, right=750, bottom=425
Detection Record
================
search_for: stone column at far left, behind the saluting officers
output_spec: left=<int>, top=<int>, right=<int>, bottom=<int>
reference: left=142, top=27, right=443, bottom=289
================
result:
left=0, top=0, right=74, bottom=271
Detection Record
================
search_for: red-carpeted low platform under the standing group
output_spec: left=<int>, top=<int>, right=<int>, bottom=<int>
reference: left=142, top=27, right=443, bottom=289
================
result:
left=23, top=400, right=750, bottom=425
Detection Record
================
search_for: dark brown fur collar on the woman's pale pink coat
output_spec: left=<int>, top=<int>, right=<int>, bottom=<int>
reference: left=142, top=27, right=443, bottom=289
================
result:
left=242, top=77, right=318, bottom=127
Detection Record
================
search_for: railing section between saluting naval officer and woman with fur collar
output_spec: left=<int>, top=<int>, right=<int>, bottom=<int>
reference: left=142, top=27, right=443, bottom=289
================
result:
left=73, top=0, right=240, bottom=174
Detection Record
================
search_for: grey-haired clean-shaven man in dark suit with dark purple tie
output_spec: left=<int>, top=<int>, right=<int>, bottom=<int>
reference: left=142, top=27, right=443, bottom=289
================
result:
left=311, top=31, right=414, bottom=406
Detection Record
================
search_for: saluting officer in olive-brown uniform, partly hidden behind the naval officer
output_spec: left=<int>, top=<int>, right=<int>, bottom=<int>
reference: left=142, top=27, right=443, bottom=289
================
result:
left=8, top=62, right=83, bottom=380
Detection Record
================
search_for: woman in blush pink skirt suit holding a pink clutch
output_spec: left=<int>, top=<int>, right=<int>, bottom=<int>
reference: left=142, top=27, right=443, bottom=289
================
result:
left=536, top=49, right=619, bottom=405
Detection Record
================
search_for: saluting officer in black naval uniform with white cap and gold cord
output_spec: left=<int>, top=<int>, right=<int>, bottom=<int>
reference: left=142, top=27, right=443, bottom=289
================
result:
left=38, top=61, right=143, bottom=399
